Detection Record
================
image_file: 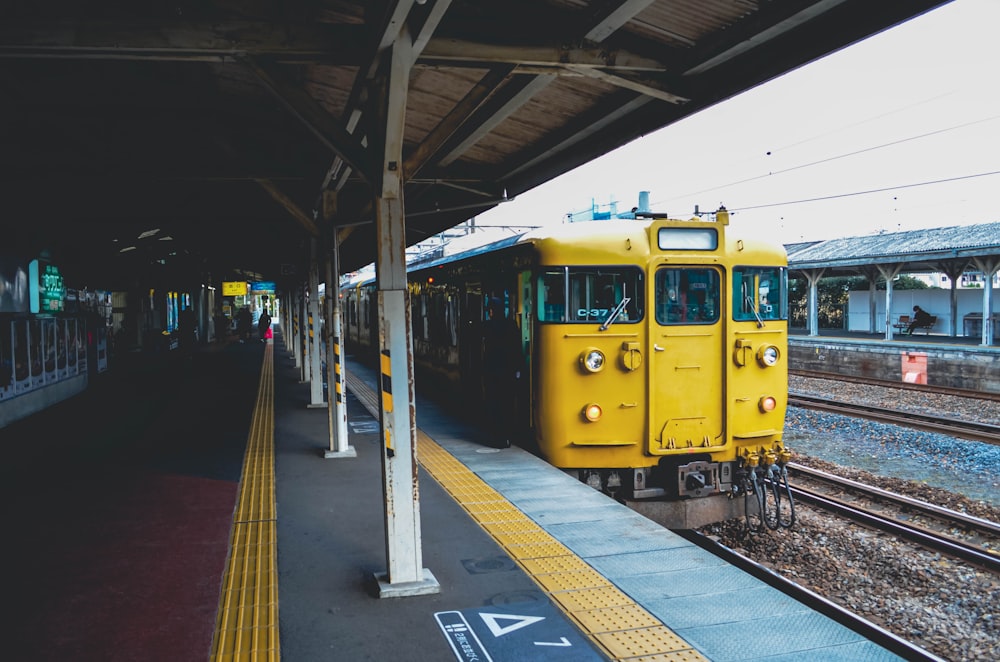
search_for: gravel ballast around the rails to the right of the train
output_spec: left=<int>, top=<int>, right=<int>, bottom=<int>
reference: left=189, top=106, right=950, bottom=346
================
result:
left=701, top=376, right=1000, bottom=662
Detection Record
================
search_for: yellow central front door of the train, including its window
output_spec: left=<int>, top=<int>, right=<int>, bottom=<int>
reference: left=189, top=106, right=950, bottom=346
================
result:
left=648, top=266, right=725, bottom=455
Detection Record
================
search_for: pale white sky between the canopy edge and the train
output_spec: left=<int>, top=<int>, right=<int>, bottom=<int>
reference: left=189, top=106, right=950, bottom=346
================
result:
left=468, top=0, right=1000, bottom=244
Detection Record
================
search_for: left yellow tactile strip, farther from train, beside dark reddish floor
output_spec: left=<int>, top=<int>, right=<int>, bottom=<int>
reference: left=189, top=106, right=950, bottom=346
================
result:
left=210, top=344, right=281, bottom=662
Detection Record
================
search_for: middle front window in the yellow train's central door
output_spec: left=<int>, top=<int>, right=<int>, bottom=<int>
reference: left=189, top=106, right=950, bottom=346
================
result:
left=655, top=267, right=720, bottom=326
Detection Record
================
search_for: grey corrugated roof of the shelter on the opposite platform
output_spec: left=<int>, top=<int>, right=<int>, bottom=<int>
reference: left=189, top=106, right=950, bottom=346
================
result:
left=785, top=222, right=1000, bottom=276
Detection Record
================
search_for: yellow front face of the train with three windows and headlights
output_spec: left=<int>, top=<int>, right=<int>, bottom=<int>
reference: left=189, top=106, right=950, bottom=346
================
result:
left=534, top=212, right=788, bottom=499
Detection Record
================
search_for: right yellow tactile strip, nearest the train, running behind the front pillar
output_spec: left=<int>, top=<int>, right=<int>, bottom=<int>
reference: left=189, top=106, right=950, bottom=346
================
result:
left=347, top=368, right=705, bottom=662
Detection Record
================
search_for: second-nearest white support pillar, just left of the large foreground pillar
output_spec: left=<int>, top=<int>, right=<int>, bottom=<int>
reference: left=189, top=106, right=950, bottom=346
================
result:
left=323, top=231, right=358, bottom=458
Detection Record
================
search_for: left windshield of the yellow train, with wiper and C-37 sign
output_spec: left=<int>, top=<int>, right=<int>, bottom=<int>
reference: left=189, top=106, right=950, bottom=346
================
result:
left=538, top=267, right=643, bottom=324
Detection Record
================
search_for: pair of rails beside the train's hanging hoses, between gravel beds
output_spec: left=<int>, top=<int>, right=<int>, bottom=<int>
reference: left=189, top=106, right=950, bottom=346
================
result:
left=788, top=463, right=1000, bottom=574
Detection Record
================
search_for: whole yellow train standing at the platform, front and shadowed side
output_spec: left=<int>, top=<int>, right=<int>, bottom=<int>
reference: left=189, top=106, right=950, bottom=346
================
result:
left=344, top=209, right=788, bottom=526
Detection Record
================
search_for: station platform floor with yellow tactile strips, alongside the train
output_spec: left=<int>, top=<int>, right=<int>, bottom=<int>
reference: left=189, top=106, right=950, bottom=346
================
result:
left=0, top=333, right=928, bottom=662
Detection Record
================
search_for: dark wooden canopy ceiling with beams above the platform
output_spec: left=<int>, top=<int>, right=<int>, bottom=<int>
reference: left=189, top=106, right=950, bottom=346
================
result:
left=0, top=0, right=946, bottom=289
